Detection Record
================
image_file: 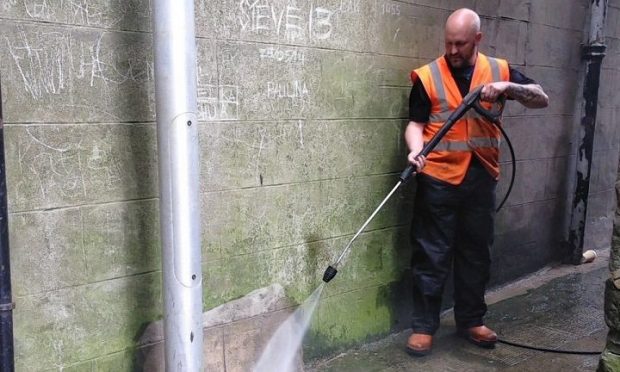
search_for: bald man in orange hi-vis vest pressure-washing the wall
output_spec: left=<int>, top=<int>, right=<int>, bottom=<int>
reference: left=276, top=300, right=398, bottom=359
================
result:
left=405, top=9, right=548, bottom=356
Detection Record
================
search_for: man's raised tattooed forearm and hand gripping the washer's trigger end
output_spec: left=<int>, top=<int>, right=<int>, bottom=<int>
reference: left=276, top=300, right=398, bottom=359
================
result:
left=480, top=81, right=549, bottom=108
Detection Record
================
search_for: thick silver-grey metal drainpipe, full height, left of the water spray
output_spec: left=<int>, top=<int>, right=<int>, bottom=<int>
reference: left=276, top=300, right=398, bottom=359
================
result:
left=152, top=0, right=203, bottom=372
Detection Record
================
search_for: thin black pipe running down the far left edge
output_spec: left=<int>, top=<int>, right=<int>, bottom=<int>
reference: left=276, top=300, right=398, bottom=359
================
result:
left=0, top=77, right=15, bottom=372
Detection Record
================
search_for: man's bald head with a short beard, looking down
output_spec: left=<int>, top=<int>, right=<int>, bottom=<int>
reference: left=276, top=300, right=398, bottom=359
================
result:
left=445, top=8, right=482, bottom=68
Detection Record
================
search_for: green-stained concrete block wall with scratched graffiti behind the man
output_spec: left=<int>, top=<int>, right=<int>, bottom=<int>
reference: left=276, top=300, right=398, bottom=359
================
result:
left=0, top=0, right=620, bottom=371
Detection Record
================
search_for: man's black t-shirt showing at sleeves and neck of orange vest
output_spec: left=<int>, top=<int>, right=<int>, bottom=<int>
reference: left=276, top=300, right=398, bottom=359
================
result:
left=409, top=56, right=536, bottom=123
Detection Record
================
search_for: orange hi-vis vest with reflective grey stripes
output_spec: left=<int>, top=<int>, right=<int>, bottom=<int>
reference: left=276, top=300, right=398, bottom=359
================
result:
left=411, top=53, right=510, bottom=185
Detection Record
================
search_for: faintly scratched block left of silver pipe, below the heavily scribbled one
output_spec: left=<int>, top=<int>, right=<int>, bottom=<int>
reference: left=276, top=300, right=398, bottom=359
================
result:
left=10, top=124, right=155, bottom=209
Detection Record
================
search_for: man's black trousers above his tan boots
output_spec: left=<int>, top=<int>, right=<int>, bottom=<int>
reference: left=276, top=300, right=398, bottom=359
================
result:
left=411, top=160, right=497, bottom=335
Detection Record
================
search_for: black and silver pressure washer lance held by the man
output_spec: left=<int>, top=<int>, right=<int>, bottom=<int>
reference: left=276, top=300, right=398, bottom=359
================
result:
left=323, top=85, right=506, bottom=283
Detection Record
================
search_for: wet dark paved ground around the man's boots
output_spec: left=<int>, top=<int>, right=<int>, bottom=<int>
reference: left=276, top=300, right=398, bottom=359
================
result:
left=305, top=251, right=609, bottom=372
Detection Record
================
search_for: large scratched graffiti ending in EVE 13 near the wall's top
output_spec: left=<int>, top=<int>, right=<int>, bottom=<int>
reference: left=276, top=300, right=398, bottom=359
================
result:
left=237, top=0, right=334, bottom=41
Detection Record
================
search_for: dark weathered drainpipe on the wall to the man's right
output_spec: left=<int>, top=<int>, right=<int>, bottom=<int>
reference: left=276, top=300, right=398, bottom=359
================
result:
left=568, top=0, right=608, bottom=264
